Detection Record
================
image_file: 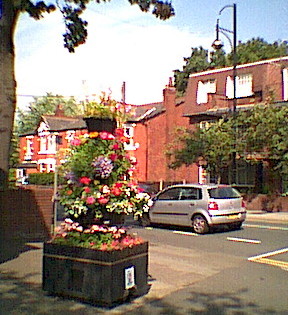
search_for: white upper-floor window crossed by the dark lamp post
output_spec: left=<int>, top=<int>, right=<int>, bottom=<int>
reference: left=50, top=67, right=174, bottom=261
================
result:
left=226, top=74, right=253, bottom=98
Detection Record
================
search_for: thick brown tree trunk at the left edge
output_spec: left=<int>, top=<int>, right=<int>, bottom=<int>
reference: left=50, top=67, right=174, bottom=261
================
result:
left=0, top=0, right=17, bottom=189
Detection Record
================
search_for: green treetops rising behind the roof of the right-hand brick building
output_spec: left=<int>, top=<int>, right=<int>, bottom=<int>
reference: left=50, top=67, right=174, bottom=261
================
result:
left=174, top=38, right=288, bottom=95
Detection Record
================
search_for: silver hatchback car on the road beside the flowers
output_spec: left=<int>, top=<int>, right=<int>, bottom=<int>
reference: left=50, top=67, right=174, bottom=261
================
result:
left=141, top=184, right=246, bottom=234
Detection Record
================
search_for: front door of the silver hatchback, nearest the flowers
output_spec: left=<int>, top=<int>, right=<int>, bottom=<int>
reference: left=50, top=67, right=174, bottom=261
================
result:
left=149, top=187, right=181, bottom=225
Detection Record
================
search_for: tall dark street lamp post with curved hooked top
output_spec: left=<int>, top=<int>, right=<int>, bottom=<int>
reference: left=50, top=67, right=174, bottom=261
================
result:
left=212, top=3, right=237, bottom=184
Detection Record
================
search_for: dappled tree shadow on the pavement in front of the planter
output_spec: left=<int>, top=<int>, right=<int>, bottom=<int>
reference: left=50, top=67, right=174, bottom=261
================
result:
left=0, top=272, right=284, bottom=315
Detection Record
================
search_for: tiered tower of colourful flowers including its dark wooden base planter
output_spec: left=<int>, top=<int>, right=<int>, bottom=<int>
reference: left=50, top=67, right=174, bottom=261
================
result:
left=43, top=98, right=151, bottom=307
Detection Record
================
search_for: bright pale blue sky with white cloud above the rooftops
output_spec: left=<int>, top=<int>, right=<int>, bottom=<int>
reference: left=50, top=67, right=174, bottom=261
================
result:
left=15, top=0, right=288, bottom=106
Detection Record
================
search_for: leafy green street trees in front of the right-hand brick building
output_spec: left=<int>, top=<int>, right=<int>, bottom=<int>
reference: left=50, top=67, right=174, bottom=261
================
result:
left=166, top=104, right=288, bottom=181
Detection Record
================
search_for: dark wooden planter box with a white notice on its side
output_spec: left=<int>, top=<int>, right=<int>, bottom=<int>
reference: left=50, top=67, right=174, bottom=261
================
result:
left=42, top=242, right=149, bottom=307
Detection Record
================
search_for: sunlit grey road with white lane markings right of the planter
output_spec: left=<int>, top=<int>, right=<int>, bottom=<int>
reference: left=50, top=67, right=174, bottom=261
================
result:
left=128, top=222, right=288, bottom=314
